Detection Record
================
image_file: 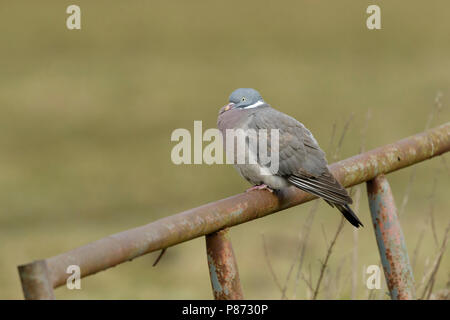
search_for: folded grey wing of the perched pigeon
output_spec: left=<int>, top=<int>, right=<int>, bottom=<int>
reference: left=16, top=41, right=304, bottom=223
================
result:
left=250, top=108, right=352, bottom=205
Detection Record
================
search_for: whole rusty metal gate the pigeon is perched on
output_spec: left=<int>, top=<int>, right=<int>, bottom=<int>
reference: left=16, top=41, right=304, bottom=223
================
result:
left=18, top=122, right=450, bottom=299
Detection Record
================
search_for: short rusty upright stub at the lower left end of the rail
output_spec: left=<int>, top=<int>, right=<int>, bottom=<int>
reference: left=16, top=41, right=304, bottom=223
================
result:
left=18, top=260, right=55, bottom=300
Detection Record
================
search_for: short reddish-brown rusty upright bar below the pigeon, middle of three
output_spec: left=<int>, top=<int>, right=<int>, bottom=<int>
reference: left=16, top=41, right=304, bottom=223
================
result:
left=205, top=229, right=244, bottom=300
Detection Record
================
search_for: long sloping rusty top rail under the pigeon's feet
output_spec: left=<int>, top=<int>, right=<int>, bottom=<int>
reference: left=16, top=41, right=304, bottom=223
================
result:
left=18, top=122, right=450, bottom=288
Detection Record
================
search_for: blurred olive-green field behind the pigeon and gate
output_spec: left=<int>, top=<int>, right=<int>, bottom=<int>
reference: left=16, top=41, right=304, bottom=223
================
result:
left=0, top=0, right=450, bottom=299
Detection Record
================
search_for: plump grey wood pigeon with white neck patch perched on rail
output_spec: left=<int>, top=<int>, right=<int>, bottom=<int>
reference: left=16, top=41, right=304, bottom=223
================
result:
left=217, top=88, right=363, bottom=228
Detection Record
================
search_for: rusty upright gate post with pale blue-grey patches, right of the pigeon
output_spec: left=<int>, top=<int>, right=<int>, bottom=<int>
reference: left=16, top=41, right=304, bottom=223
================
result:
left=367, top=174, right=416, bottom=300
